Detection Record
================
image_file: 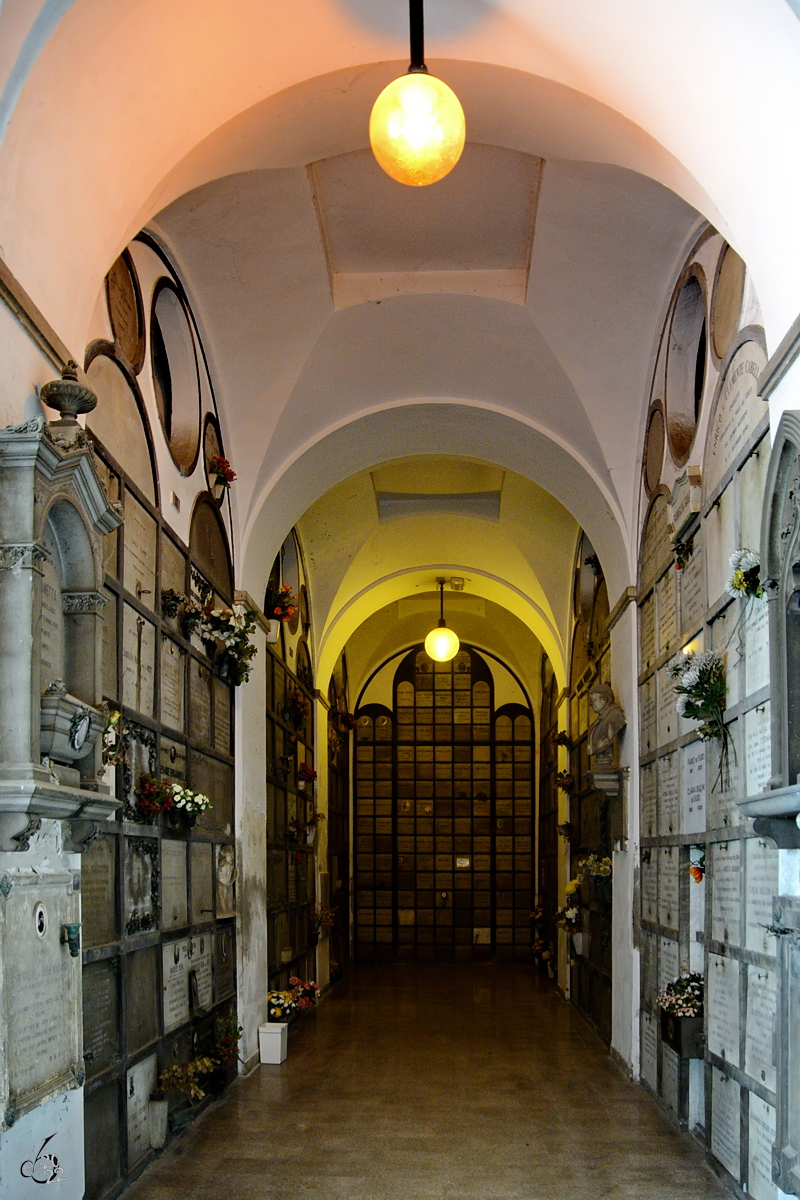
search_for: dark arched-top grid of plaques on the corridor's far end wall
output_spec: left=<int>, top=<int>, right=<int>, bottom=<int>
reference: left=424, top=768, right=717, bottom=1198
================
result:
left=355, top=648, right=533, bottom=961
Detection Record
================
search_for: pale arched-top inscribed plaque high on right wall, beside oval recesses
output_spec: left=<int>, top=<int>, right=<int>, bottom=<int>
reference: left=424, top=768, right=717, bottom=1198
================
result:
left=704, top=342, right=766, bottom=496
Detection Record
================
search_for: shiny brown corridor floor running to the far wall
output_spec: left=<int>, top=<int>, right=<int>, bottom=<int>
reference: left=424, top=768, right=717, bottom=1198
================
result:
left=125, top=964, right=729, bottom=1200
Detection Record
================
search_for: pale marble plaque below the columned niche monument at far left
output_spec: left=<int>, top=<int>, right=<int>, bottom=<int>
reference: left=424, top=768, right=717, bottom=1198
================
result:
left=2, top=874, right=80, bottom=1106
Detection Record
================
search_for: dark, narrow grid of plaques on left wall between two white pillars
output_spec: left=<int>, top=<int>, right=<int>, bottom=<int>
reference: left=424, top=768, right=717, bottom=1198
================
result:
left=265, top=646, right=317, bottom=990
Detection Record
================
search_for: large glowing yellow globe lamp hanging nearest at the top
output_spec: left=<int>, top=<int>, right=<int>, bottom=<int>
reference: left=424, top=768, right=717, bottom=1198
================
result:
left=369, top=72, right=467, bottom=187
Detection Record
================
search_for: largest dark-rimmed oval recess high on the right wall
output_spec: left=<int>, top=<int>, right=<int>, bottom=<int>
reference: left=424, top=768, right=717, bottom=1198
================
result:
left=666, top=265, right=708, bottom=467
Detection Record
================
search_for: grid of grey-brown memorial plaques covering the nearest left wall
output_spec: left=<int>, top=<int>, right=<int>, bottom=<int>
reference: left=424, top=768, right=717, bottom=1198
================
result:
left=82, top=446, right=236, bottom=1200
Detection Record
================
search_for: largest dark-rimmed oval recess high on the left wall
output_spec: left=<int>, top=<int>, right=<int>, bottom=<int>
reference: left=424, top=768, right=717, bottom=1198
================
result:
left=150, top=280, right=200, bottom=475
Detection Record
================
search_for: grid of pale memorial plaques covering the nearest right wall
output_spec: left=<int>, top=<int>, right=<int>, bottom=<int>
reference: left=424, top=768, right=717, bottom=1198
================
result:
left=638, top=381, right=778, bottom=1200
